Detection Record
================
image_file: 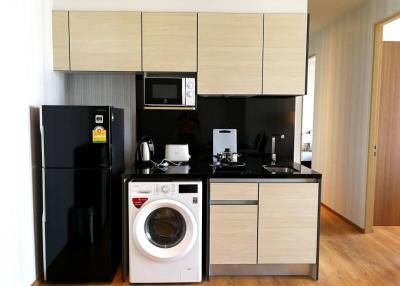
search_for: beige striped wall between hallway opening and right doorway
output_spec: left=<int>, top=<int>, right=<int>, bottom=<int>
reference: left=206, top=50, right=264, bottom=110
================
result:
left=310, top=0, right=400, bottom=228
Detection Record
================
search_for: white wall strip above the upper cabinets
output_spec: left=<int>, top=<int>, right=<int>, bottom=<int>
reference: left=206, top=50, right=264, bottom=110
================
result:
left=53, top=0, right=308, bottom=13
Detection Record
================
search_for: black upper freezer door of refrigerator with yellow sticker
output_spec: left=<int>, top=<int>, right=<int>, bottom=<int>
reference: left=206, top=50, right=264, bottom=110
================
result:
left=41, top=105, right=111, bottom=168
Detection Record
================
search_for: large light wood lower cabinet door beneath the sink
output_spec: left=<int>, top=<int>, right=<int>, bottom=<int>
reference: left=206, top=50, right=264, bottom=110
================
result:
left=258, top=183, right=319, bottom=264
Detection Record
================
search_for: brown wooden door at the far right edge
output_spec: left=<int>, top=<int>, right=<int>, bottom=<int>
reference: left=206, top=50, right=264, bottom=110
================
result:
left=374, top=42, right=400, bottom=225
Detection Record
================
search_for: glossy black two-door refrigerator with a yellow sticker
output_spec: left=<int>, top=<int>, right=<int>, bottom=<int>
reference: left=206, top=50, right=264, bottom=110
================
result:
left=40, top=105, right=124, bottom=283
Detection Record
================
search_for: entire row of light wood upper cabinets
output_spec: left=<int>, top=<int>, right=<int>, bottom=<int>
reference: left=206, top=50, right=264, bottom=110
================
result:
left=53, top=11, right=308, bottom=96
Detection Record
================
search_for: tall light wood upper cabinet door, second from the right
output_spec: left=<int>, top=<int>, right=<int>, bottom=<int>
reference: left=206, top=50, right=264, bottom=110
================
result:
left=197, top=13, right=263, bottom=95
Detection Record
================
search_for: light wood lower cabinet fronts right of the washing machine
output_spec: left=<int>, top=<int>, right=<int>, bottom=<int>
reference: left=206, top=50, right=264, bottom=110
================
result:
left=210, top=182, right=319, bottom=266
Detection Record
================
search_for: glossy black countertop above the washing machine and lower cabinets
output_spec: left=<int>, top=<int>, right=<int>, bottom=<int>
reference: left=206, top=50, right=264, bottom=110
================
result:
left=123, top=157, right=322, bottom=179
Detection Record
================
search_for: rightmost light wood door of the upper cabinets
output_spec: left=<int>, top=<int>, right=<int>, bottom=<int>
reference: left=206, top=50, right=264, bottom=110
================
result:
left=263, top=14, right=308, bottom=95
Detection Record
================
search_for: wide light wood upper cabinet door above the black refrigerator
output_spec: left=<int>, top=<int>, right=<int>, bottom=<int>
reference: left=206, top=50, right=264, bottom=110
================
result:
left=69, top=11, right=142, bottom=71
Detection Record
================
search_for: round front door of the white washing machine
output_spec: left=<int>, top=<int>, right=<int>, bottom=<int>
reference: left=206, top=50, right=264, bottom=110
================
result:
left=132, top=199, right=198, bottom=261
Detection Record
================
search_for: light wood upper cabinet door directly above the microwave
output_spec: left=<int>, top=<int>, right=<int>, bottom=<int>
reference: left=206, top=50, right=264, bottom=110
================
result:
left=142, top=13, right=197, bottom=72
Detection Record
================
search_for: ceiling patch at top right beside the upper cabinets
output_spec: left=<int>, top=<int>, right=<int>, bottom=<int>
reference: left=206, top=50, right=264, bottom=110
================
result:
left=308, top=0, right=365, bottom=34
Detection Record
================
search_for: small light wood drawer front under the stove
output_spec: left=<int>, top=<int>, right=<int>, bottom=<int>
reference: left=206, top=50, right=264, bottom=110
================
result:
left=210, top=183, right=258, bottom=201
